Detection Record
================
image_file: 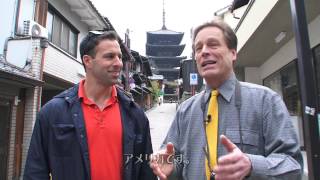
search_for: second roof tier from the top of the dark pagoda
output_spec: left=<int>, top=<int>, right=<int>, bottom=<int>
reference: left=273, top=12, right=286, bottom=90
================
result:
left=146, top=44, right=185, bottom=56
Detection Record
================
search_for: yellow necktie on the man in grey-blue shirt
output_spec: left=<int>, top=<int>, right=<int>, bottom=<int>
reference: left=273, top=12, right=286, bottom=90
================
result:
left=205, top=90, right=219, bottom=180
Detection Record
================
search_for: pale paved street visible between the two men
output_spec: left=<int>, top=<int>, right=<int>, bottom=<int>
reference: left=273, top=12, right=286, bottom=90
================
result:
left=146, top=103, right=176, bottom=151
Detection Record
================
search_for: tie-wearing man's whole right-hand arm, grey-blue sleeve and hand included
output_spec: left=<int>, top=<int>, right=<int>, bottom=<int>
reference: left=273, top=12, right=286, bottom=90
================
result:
left=213, top=95, right=302, bottom=180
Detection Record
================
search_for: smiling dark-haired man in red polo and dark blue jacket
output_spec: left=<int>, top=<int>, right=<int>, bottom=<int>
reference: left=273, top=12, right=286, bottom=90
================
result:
left=24, top=31, right=156, bottom=180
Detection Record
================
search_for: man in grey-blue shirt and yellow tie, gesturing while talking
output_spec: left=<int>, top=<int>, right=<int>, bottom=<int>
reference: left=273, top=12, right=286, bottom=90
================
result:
left=150, top=19, right=302, bottom=180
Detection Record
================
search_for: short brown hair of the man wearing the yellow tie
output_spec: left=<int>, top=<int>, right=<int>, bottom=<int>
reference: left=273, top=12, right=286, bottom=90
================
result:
left=192, top=18, right=238, bottom=52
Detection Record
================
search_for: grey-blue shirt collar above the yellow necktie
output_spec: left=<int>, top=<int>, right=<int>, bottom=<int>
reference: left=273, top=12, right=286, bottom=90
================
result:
left=205, top=73, right=237, bottom=102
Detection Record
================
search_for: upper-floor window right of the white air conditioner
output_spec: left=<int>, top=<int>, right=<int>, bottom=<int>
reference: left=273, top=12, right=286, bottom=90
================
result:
left=47, top=5, right=79, bottom=57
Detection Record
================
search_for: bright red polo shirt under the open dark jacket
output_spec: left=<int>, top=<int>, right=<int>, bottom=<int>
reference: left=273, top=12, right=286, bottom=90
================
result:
left=78, top=80, right=122, bottom=180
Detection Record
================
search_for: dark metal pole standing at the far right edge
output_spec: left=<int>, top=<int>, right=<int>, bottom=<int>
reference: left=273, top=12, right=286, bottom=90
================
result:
left=290, top=0, right=320, bottom=180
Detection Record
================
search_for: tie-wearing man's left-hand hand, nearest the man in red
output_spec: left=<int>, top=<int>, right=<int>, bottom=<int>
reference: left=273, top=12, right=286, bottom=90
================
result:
left=150, top=143, right=174, bottom=180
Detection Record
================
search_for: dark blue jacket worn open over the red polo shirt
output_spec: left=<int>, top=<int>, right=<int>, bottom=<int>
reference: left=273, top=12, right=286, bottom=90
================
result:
left=24, top=85, right=156, bottom=180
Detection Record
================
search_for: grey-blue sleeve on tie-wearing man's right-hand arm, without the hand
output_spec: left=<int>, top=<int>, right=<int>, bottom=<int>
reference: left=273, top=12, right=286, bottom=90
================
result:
left=247, top=95, right=303, bottom=180
